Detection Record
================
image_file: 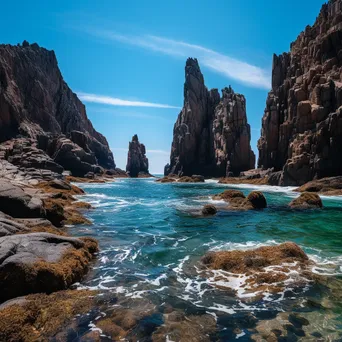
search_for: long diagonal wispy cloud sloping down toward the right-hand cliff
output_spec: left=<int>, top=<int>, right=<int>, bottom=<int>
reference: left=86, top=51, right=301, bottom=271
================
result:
left=86, top=29, right=271, bottom=89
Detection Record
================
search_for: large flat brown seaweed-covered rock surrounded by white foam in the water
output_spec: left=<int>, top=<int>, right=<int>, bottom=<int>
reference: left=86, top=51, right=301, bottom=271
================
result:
left=202, top=242, right=314, bottom=295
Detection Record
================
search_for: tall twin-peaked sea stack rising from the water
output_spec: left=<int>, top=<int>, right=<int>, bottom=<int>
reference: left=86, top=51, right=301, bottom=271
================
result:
left=164, top=58, right=255, bottom=177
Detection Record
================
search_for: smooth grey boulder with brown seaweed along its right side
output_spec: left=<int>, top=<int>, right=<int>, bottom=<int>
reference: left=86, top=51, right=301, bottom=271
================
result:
left=0, top=233, right=97, bottom=302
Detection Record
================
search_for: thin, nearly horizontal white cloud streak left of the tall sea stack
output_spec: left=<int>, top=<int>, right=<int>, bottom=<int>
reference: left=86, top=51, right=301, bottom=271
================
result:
left=77, top=92, right=180, bottom=109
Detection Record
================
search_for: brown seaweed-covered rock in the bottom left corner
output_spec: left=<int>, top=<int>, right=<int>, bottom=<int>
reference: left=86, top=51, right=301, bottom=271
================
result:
left=0, top=290, right=97, bottom=342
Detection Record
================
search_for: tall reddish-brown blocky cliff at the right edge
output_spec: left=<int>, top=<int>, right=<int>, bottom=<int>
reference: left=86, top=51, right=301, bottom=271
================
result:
left=258, top=0, right=342, bottom=185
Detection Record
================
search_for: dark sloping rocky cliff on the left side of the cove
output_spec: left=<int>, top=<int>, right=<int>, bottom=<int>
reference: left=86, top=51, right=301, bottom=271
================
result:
left=0, top=41, right=115, bottom=176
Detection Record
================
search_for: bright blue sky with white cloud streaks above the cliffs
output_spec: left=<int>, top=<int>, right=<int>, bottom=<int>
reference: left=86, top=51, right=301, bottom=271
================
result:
left=0, top=0, right=324, bottom=172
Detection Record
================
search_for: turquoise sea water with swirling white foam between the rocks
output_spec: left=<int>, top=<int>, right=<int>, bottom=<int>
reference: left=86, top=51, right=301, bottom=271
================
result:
left=70, top=179, right=342, bottom=341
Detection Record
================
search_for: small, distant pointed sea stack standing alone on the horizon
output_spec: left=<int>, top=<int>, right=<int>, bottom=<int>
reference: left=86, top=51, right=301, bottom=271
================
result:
left=126, top=134, right=149, bottom=177
